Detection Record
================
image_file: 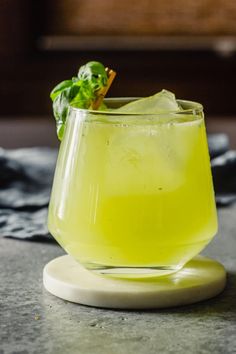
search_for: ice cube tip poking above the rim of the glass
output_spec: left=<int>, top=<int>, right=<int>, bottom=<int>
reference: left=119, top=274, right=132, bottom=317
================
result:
left=117, top=90, right=181, bottom=114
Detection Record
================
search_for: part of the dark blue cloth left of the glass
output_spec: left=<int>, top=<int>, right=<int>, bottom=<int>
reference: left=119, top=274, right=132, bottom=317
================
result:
left=0, top=148, right=57, bottom=240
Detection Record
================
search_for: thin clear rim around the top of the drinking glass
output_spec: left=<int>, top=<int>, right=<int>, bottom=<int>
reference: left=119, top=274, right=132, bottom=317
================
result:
left=70, top=97, right=203, bottom=117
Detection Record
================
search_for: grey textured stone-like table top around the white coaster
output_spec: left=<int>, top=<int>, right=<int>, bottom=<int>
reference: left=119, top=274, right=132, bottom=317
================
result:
left=0, top=206, right=236, bottom=354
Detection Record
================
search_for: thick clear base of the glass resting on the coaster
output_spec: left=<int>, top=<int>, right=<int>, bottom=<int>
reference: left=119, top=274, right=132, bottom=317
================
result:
left=83, top=263, right=183, bottom=279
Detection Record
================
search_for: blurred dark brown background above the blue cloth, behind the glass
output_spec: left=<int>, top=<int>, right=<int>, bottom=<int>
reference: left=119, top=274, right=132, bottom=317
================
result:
left=0, top=0, right=236, bottom=148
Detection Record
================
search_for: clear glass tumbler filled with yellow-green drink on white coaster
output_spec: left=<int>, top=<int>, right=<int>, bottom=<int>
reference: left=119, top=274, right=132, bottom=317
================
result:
left=48, top=98, right=217, bottom=277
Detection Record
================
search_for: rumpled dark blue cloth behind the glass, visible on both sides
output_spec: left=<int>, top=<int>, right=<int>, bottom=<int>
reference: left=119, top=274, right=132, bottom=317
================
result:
left=0, top=134, right=236, bottom=241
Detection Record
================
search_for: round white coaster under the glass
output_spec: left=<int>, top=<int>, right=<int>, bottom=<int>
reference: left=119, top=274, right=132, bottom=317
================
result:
left=43, top=255, right=226, bottom=309
